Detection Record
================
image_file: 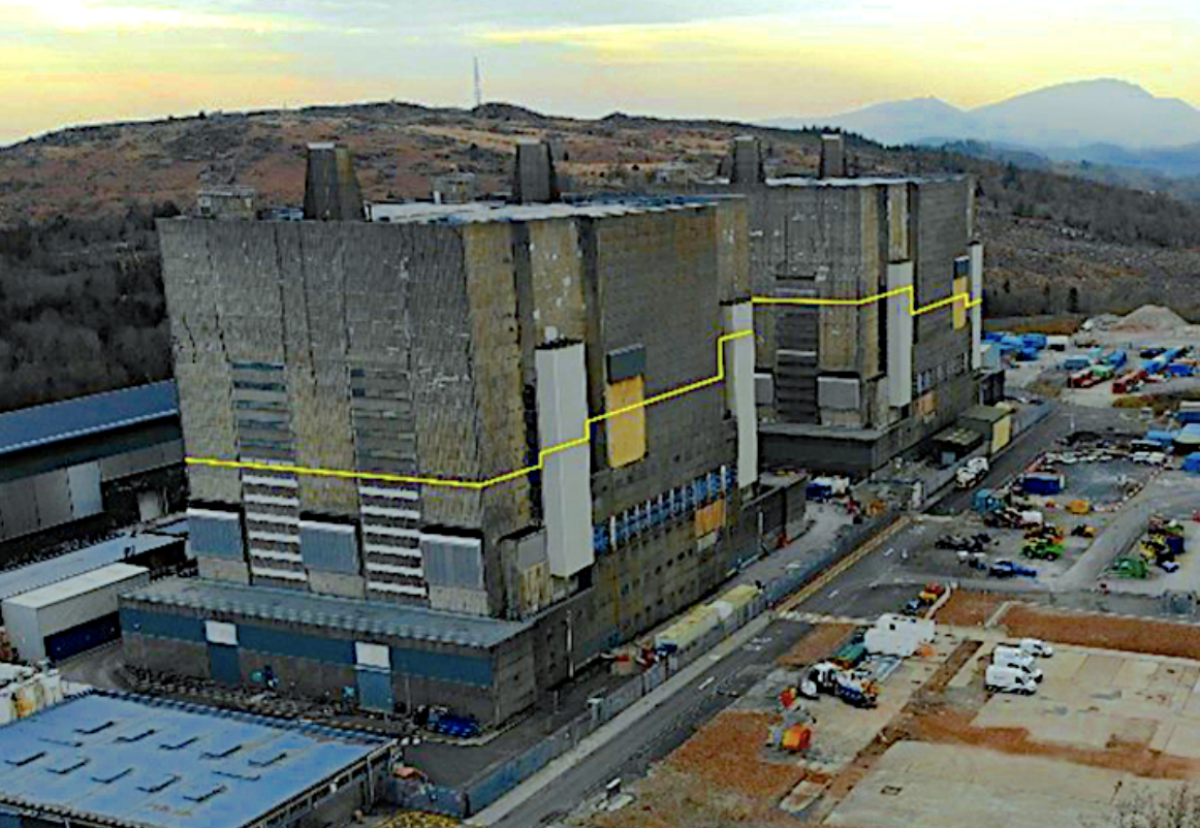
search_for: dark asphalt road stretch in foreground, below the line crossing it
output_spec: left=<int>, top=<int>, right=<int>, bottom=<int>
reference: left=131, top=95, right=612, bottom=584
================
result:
left=482, top=620, right=811, bottom=828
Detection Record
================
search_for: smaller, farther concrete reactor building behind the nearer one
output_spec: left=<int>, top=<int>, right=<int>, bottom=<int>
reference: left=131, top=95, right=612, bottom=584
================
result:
left=730, top=136, right=983, bottom=475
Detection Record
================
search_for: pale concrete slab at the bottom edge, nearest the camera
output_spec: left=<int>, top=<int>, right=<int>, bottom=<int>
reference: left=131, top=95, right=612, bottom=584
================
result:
left=824, top=742, right=1178, bottom=828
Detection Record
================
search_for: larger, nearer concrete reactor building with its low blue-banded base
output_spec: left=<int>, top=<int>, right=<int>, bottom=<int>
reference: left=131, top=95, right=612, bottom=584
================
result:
left=121, top=145, right=758, bottom=722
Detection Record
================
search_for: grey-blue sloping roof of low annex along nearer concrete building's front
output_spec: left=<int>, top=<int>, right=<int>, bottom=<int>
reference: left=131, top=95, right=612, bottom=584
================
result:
left=125, top=578, right=529, bottom=649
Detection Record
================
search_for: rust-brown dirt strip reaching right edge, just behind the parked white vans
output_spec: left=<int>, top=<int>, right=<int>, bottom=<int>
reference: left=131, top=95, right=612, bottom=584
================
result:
left=998, top=596, right=1200, bottom=660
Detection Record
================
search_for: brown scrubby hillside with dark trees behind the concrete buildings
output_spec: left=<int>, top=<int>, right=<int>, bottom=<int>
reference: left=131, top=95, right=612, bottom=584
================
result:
left=0, top=102, right=1200, bottom=409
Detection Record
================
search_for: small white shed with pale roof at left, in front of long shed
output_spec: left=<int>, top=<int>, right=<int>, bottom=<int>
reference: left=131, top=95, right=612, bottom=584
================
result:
left=2, top=556, right=150, bottom=664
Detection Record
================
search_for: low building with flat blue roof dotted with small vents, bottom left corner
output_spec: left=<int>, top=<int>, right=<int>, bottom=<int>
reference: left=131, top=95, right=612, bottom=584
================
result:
left=0, top=692, right=395, bottom=828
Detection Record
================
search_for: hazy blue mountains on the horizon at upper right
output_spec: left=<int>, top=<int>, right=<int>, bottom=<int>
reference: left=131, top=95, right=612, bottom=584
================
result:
left=766, top=78, right=1200, bottom=175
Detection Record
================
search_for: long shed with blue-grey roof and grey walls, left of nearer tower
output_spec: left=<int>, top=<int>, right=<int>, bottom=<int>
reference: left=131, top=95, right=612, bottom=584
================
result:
left=0, top=382, right=186, bottom=563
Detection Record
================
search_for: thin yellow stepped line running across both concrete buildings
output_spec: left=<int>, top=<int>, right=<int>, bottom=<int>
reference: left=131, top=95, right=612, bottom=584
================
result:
left=184, top=286, right=983, bottom=491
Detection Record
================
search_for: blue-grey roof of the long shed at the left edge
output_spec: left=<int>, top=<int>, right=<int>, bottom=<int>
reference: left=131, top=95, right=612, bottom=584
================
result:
left=0, top=380, right=179, bottom=455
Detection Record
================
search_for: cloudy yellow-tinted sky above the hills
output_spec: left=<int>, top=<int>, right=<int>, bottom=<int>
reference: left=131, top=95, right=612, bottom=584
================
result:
left=0, top=0, right=1200, bottom=144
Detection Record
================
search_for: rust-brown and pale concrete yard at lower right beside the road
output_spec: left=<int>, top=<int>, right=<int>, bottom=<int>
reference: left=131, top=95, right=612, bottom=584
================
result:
left=569, top=593, right=1200, bottom=828
